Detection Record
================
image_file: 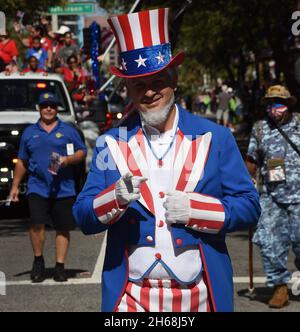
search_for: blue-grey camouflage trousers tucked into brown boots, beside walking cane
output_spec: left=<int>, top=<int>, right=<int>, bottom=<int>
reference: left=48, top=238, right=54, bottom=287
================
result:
left=252, top=196, right=300, bottom=287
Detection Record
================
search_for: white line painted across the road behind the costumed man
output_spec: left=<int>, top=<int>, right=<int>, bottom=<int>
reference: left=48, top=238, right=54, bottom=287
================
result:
left=6, top=276, right=297, bottom=286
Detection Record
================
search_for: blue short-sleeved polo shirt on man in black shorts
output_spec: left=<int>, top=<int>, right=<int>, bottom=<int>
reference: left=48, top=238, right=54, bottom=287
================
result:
left=18, top=120, right=86, bottom=198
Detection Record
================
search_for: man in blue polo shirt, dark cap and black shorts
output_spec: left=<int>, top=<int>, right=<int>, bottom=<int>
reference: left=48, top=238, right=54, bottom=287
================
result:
left=9, top=92, right=86, bottom=282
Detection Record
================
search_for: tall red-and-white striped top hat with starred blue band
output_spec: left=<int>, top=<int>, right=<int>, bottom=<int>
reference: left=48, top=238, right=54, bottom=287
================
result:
left=108, top=8, right=184, bottom=78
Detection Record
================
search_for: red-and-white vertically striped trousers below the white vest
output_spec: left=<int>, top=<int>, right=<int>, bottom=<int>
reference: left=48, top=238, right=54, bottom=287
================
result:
left=116, top=278, right=212, bottom=312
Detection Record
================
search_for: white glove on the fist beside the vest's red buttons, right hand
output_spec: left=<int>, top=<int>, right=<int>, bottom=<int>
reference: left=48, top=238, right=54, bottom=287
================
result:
left=163, top=191, right=190, bottom=225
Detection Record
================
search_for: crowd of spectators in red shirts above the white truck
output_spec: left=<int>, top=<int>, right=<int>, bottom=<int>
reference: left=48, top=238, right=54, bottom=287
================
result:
left=0, top=16, right=95, bottom=109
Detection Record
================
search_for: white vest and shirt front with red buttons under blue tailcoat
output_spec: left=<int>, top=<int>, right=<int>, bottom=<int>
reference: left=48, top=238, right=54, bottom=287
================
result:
left=129, top=109, right=202, bottom=283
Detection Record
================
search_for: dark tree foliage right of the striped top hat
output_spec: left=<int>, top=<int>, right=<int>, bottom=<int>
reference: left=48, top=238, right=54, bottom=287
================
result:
left=100, top=0, right=296, bottom=92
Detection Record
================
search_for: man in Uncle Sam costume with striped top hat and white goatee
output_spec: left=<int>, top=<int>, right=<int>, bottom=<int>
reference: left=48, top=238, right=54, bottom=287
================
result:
left=73, top=8, right=260, bottom=312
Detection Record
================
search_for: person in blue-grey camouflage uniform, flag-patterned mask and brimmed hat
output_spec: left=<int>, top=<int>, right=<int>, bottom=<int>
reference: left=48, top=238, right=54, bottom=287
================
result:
left=247, top=85, right=300, bottom=308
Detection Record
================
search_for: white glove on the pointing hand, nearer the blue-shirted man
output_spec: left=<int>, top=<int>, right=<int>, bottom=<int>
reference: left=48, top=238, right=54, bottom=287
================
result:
left=115, top=173, right=147, bottom=205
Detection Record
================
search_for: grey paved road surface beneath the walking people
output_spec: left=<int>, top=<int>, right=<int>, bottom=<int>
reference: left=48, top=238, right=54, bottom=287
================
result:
left=0, top=219, right=300, bottom=312
